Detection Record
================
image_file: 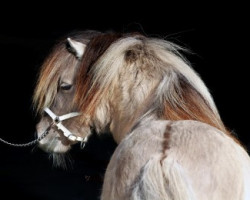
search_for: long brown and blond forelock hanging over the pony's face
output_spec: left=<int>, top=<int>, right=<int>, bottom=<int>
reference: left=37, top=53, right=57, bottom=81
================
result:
left=33, top=30, right=101, bottom=113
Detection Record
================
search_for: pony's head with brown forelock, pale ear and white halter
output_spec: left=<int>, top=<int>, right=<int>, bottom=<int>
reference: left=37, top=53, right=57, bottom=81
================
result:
left=34, top=31, right=99, bottom=155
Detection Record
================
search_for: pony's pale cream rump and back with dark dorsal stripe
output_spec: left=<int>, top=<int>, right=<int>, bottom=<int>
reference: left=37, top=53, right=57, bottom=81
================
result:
left=102, top=120, right=250, bottom=200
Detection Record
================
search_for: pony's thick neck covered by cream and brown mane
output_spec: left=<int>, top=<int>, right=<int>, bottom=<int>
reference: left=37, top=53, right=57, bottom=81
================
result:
left=75, top=34, right=229, bottom=143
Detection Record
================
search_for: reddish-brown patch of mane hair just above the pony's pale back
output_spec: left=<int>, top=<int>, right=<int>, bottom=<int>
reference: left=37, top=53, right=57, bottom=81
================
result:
left=161, top=73, right=228, bottom=133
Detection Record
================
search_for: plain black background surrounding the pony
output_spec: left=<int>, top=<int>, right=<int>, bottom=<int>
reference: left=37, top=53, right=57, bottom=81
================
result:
left=0, top=2, right=250, bottom=200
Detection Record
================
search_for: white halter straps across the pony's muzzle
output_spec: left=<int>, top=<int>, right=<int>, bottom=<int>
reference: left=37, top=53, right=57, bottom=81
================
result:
left=44, top=108, right=87, bottom=142
